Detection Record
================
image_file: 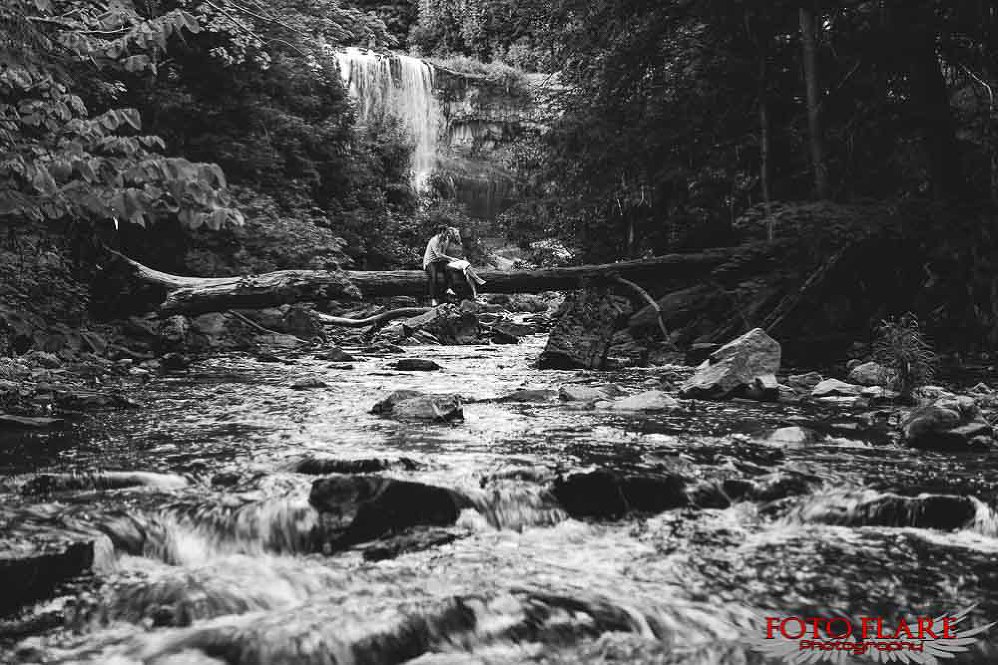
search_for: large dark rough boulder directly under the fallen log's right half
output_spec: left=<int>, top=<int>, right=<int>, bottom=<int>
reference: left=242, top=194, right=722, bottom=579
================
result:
left=537, top=289, right=631, bottom=369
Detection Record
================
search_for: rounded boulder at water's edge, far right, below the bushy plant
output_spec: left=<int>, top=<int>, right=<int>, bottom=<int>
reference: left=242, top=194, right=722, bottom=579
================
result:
left=901, top=396, right=995, bottom=452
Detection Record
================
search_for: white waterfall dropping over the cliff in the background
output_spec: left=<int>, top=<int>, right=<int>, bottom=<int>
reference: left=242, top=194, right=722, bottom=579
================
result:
left=335, top=48, right=440, bottom=189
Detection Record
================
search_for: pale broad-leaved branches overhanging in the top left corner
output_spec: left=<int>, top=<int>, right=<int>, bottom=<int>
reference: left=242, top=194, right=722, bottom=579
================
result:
left=0, top=0, right=242, bottom=236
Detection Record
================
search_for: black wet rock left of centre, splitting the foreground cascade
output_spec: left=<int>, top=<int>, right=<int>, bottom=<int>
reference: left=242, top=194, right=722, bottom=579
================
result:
left=309, top=475, right=472, bottom=549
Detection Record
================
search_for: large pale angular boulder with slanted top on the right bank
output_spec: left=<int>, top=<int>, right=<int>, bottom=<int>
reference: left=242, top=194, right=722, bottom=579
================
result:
left=680, top=328, right=781, bottom=399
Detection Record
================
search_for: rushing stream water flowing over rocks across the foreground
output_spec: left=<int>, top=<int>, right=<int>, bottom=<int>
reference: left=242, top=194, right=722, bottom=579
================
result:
left=0, top=338, right=998, bottom=665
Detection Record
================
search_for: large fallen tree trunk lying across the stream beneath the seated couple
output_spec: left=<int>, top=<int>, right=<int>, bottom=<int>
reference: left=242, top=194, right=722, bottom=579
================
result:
left=94, top=249, right=732, bottom=318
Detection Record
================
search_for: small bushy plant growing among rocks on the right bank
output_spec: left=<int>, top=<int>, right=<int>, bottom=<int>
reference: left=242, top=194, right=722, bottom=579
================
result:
left=873, top=312, right=938, bottom=400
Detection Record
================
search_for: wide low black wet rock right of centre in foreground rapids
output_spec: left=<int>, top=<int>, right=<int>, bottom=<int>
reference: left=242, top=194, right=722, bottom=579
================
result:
left=552, top=470, right=689, bottom=519
